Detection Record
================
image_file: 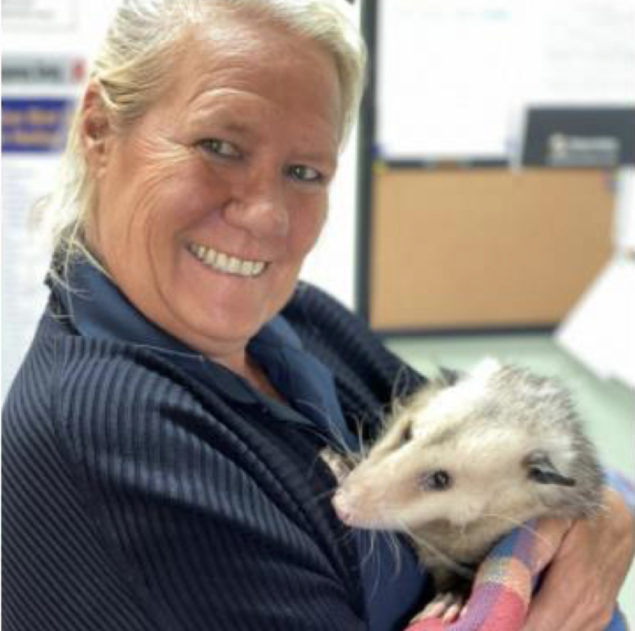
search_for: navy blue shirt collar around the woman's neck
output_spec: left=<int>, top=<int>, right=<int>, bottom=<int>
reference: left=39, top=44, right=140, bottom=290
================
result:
left=48, top=258, right=357, bottom=448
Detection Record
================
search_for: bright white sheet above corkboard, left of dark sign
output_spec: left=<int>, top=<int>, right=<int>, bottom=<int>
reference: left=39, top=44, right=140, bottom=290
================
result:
left=376, top=0, right=515, bottom=159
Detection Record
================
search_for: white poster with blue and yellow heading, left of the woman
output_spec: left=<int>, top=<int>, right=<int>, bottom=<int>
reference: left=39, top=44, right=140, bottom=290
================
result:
left=2, top=87, right=75, bottom=399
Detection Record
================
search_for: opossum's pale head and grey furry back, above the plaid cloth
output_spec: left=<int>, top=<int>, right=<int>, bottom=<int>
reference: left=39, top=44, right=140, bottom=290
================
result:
left=333, top=360, right=601, bottom=531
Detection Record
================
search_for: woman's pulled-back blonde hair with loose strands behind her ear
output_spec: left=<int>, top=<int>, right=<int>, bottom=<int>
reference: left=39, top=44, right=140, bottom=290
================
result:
left=47, top=0, right=366, bottom=264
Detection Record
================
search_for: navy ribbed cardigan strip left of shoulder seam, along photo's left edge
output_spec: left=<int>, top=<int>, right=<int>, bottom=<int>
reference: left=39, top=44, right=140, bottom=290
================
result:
left=2, top=320, right=157, bottom=631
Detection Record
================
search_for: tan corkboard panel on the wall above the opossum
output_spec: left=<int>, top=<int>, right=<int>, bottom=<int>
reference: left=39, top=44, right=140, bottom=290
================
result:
left=369, top=169, right=613, bottom=330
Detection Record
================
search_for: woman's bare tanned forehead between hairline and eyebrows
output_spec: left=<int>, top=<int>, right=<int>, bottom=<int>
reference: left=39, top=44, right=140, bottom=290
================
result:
left=164, top=25, right=342, bottom=144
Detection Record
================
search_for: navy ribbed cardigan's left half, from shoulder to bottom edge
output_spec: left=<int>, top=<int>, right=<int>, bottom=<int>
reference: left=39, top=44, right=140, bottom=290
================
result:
left=3, top=312, right=365, bottom=631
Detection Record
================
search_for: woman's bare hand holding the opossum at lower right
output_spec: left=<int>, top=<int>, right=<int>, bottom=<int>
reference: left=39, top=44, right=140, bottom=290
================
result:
left=523, top=488, right=635, bottom=631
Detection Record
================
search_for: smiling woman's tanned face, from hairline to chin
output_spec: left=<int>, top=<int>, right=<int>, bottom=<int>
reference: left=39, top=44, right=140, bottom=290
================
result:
left=85, top=21, right=342, bottom=365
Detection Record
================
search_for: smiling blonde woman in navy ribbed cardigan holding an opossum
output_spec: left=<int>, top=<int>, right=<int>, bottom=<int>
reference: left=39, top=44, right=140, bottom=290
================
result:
left=4, top=0, right=631, bottom=631
